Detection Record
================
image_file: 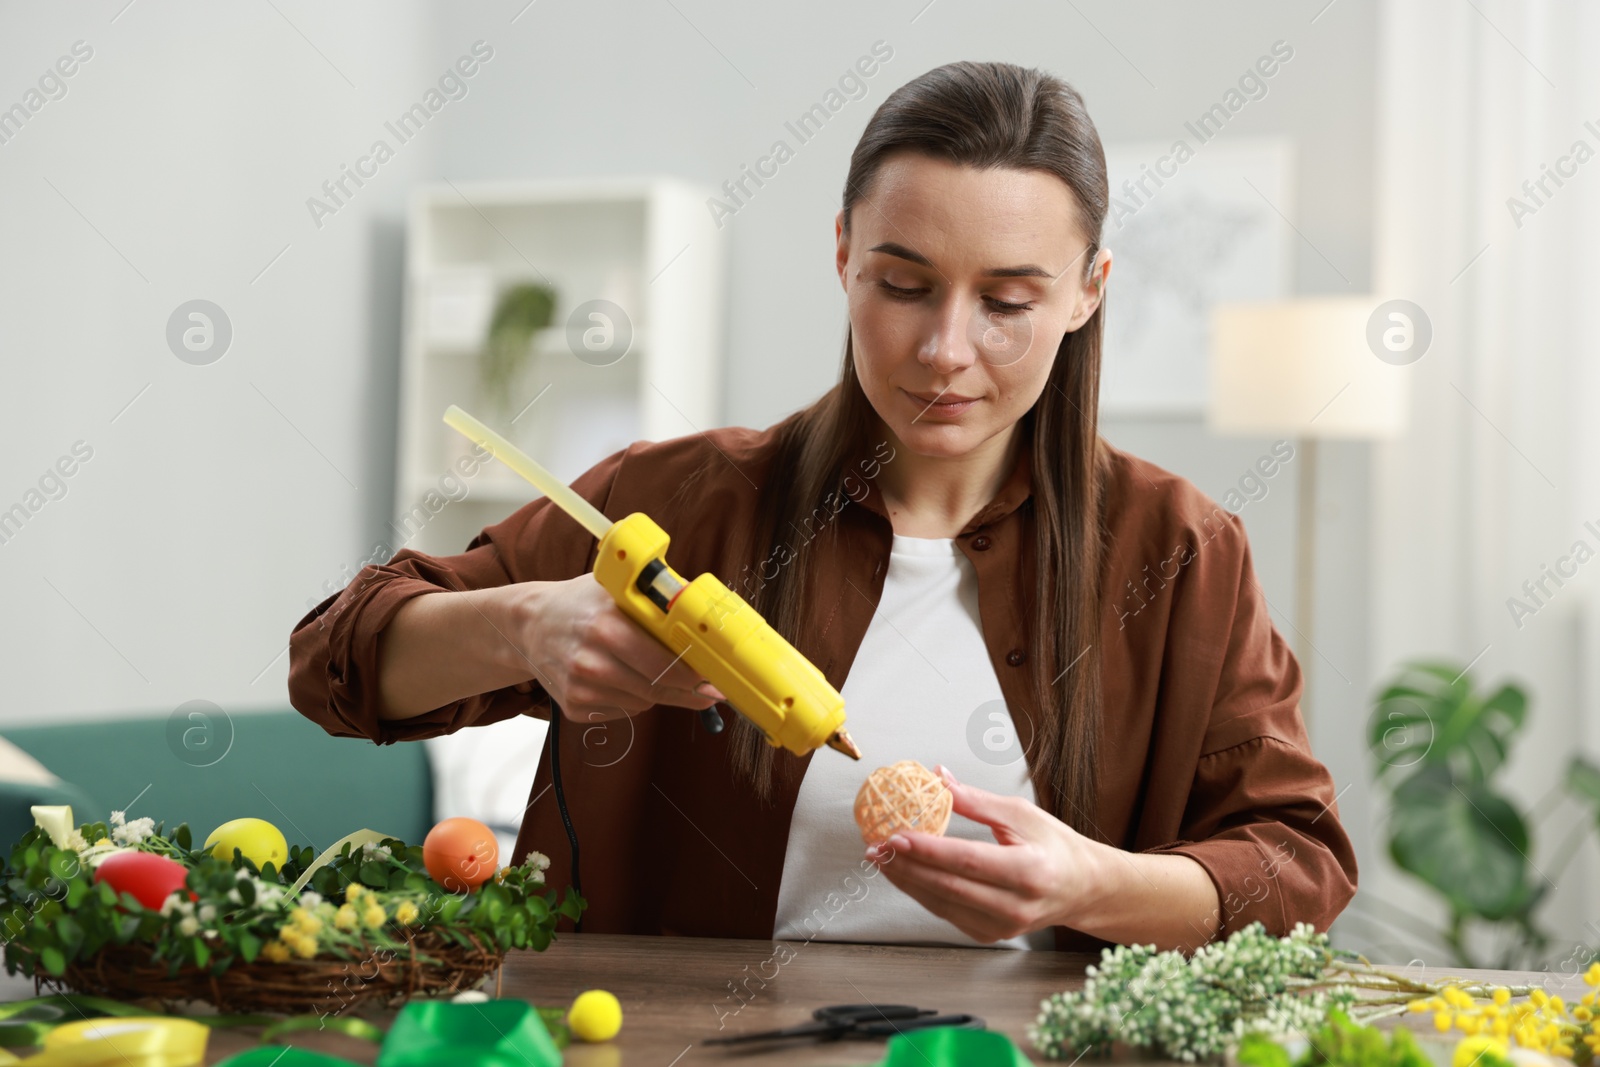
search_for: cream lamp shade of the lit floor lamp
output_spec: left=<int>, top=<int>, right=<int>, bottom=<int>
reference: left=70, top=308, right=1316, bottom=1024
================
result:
left=1206, top=296, right=1408, bottom=438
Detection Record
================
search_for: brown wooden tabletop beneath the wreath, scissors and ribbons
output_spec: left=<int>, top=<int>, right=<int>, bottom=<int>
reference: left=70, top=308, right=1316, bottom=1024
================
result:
left=0, top=934, right=1584, bottom=1067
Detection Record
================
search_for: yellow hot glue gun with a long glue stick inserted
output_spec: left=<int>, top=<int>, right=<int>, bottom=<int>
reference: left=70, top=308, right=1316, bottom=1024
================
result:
left=445, top=405, right=861, bottom=760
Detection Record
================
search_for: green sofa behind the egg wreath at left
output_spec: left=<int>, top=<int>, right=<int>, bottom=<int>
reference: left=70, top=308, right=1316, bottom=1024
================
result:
left=0, top=709, right=434, bottom=856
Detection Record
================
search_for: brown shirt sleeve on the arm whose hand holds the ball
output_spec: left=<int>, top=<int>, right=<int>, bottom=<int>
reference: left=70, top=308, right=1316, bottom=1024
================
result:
left=1149, top=517, right=1357, bottom=937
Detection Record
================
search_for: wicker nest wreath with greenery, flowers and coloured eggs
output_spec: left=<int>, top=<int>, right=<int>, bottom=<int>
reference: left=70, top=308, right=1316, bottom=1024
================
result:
left=0, top=808, right=584, bottom=1014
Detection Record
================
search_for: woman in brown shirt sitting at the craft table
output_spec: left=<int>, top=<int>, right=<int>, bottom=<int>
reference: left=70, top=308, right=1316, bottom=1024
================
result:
left=290, top=62, right=1355, bottom=949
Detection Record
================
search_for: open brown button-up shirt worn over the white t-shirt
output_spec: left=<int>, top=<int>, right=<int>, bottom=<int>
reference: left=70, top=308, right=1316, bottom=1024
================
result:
left=290, top=415, right=1355, bottom=949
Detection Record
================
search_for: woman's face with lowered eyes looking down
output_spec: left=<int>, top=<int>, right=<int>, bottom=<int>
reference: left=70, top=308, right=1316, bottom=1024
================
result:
left=835, top=152, right=1110, bottom=458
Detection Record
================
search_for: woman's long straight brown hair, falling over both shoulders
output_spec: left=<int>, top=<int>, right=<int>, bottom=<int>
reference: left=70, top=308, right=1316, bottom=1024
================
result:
left=730, top=62, right=1109, bottom=837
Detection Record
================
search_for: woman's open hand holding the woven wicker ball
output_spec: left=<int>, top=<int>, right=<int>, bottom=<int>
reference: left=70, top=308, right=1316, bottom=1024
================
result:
left=867, top=766, right=1106, bottom=944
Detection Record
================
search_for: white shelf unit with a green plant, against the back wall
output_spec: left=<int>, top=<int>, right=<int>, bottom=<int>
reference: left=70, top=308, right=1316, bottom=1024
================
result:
left=389, top=178, right=725, bottom=555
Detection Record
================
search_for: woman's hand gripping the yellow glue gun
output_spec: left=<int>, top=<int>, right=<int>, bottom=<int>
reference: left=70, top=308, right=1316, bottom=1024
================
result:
left=510, top=574, right=728, bottom=721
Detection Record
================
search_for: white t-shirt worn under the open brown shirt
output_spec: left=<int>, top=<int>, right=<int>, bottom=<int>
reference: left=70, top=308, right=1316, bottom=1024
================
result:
left=773, top=534, right=1054, bottom=949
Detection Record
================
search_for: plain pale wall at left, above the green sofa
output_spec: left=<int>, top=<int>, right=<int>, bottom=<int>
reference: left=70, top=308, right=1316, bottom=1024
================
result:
left=0, top=3, right=458, bottom=720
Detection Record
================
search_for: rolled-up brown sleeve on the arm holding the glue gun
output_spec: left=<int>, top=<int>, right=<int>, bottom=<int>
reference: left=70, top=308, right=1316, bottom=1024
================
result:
left=290, top=450, right=627, bottom=744
